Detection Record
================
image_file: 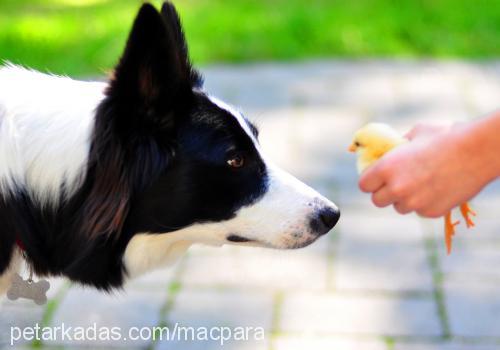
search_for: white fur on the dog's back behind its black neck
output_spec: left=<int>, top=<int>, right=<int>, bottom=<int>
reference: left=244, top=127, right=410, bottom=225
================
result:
left=0, top=65, right=105, bottom=205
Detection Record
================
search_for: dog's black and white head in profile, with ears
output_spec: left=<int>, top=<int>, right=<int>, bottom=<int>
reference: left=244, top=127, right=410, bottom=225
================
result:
left=83, top=3, right=339, bottom=254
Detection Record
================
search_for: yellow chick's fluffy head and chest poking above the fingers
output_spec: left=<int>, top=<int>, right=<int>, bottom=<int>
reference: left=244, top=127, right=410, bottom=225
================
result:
left=349, top=123, right=408, bottom=174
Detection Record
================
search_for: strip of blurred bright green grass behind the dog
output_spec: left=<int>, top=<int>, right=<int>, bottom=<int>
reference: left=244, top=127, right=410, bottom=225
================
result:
left=0, top=0, right=500, bottom=75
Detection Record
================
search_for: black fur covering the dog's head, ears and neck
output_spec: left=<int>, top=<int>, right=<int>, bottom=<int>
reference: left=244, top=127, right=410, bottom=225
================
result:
left=0, top=3, right=267, bottom=290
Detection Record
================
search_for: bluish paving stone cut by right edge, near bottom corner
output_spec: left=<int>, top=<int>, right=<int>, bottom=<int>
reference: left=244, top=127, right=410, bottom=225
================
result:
left=444, top=282, right=500, bottom=338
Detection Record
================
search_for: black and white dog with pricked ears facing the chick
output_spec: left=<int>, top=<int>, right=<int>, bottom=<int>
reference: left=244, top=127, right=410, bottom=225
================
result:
left=0, top=3, right=339, bottom=291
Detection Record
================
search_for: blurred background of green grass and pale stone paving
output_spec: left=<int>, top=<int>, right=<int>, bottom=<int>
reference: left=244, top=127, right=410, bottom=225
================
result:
left=0, top=0, right=500, bottom=350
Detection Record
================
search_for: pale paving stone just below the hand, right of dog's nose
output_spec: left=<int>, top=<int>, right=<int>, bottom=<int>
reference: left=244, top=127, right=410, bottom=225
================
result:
left=332, top=209, right=433, bottom=292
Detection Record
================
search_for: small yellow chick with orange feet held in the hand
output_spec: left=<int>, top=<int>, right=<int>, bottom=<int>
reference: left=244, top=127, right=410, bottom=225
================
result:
left=349, top=123, right=476, bottom=254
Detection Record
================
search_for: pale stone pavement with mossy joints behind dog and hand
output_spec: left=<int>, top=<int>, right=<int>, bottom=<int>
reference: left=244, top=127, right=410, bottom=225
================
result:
left=0, top=61, right=500, bottom=350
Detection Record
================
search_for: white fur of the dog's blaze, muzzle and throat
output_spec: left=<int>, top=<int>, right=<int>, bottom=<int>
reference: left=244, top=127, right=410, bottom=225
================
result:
left=124, top=97, right=335, bottom=277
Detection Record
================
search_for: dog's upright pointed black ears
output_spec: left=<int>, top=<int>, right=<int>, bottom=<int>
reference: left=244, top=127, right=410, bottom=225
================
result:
left=107, top=4, right=200, bottom=130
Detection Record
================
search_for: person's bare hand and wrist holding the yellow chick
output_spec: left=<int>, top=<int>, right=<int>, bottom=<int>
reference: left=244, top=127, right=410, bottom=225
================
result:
left=359, top=112, right=500, bottom=217
